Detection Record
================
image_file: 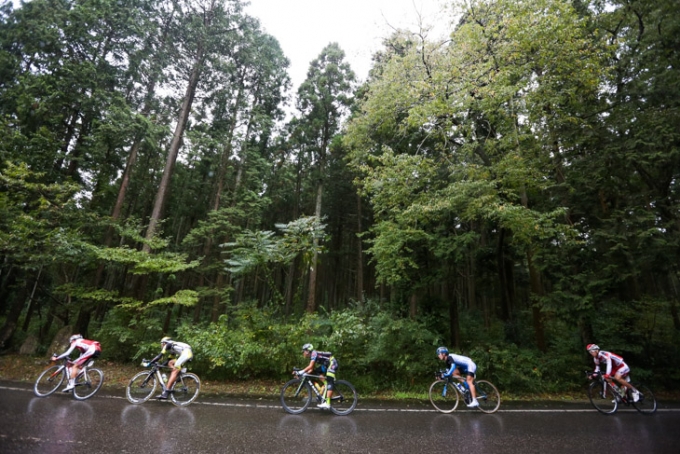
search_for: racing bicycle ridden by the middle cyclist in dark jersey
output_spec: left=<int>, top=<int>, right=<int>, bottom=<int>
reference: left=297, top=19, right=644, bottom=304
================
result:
left=281, top=369, right=358, bottom=416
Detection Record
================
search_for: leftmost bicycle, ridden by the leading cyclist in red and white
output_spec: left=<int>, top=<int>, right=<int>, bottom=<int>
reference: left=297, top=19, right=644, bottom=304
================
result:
left=33, top=358, right=104, bottom=400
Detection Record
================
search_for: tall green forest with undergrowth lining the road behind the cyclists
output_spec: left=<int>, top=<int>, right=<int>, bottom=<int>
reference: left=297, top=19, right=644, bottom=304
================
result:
left=0, top=0, right=680, bottom=393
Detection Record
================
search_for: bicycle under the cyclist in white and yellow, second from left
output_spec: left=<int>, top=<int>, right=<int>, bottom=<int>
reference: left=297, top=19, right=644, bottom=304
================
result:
left=125, top=359, right=201, bottom=407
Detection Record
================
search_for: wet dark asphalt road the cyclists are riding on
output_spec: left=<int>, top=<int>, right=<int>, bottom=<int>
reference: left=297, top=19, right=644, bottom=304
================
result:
left=0, top=383, right=680, bottom=454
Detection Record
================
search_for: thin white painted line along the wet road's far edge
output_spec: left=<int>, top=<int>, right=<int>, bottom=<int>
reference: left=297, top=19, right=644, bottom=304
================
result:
left=0, top=386, right=680, bottom=414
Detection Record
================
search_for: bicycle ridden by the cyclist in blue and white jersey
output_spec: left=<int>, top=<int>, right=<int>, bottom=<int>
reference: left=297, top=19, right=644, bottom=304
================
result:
left=428, top=371, right=501, bottom=413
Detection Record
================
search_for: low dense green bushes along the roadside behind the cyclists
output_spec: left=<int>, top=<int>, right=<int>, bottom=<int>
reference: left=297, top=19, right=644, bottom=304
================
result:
left=86, top=298, right=678, bottom=393
